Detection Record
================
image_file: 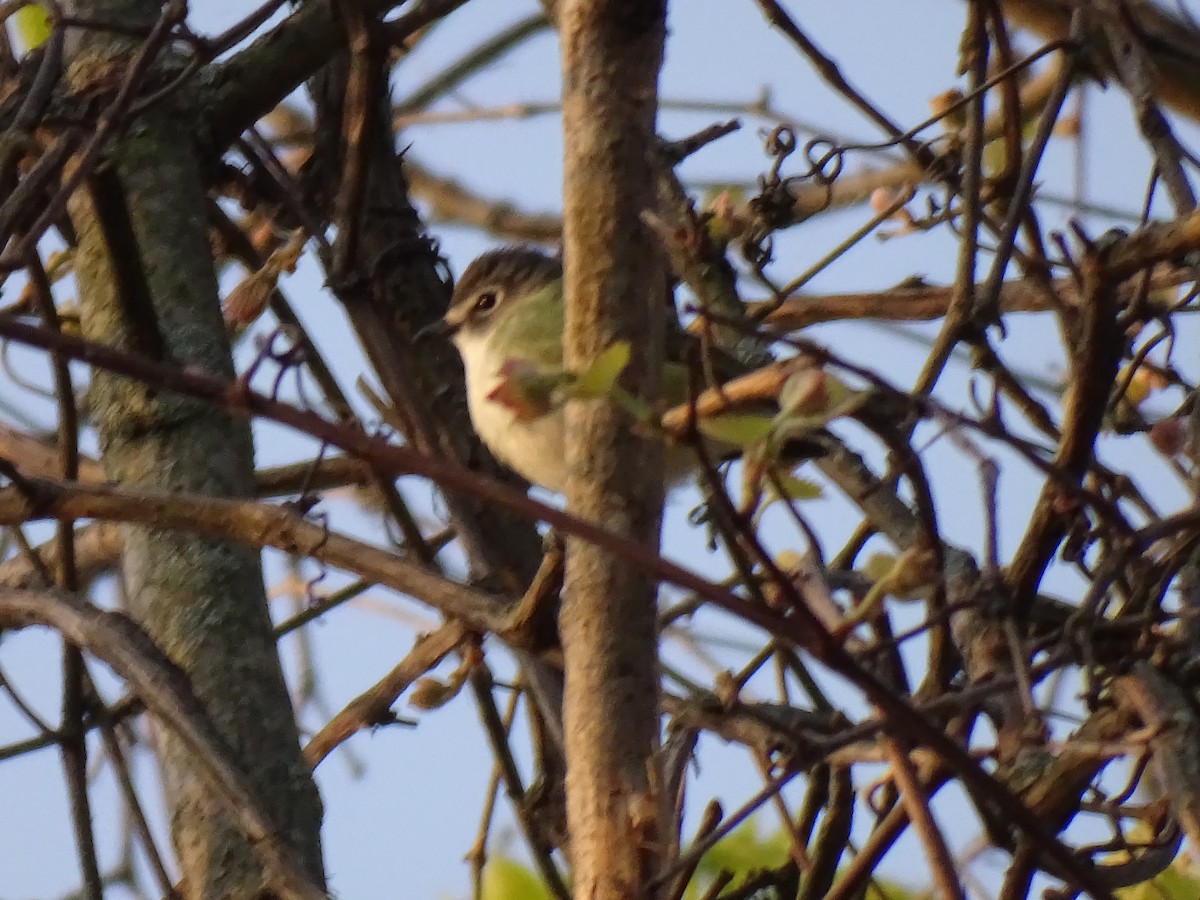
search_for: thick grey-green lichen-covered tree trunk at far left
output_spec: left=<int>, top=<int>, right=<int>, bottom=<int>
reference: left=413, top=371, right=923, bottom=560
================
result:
left=63, top=0, right=324, bottom=898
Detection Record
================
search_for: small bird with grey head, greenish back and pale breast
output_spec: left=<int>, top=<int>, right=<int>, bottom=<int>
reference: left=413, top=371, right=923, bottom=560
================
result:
left=438, top=247, right=816, bottom=493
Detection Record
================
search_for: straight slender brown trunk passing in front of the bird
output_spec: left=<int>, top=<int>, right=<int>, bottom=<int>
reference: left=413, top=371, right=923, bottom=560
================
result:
left=556, top=0, right=666, bottom=900
